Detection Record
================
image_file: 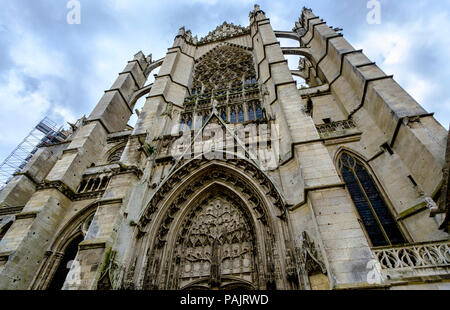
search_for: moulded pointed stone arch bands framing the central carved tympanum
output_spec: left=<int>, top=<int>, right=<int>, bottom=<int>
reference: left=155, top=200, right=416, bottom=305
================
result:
left=127, top=160, right=286, bottom=289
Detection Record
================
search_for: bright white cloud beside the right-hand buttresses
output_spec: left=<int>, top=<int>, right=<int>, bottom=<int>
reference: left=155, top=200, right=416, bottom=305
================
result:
left=355, top=12, right=450, bottom=126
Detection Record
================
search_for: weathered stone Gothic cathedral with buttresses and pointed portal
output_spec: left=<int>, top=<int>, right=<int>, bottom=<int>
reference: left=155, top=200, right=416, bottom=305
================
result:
left=0, top=6, right=450, bottom=290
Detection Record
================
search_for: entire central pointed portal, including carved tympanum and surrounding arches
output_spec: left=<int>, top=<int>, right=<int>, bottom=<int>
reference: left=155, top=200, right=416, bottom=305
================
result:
left=123, top=160, right=289, bottom=290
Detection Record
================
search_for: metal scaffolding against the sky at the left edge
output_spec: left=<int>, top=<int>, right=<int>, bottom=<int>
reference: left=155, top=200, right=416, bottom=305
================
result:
left=0, top=117, right=67, bottom=191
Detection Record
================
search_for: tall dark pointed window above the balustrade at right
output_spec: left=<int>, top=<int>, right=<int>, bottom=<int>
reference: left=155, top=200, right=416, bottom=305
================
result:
left=339, top=152, right=406, bottom=247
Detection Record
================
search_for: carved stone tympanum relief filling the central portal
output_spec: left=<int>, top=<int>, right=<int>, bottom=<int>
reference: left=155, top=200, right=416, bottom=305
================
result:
left=179, top=198, right=254, bottom=288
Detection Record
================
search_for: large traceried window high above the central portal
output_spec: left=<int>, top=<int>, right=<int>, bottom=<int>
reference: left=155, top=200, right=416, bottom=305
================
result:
left=180, top=44, right=264, bottom=130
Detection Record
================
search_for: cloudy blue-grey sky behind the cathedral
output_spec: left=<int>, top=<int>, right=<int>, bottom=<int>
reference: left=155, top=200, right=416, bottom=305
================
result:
left=0, top=0, right=450, bottom=163
